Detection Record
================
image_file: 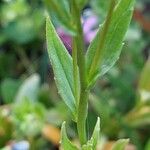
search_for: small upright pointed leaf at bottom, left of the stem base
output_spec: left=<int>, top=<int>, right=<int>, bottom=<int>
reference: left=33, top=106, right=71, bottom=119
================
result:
left=61, top=122, right=78, bottom=150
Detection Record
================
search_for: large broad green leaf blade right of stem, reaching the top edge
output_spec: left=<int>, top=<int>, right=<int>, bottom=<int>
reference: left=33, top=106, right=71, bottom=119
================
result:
left=86, top=0, right=135, bottom=86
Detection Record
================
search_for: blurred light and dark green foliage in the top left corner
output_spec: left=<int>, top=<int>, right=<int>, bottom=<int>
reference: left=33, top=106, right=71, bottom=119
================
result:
left=0, top=0, right=44, bottom=44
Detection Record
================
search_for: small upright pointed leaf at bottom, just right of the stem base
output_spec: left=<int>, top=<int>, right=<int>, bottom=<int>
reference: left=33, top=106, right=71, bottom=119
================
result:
left=82, top=117, right=100, bottom=150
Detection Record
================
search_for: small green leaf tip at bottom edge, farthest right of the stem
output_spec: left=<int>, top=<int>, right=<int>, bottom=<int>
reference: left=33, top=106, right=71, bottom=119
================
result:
left=112, top=139, right=129, bottom=150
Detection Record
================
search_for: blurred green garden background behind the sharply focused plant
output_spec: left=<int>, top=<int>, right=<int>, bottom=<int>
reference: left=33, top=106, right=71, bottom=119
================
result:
left=0, top=0, right=150, bottom=150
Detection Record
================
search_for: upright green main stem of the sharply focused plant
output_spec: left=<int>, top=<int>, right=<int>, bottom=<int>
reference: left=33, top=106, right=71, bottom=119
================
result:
left=72, top=0, right=89, bottom=145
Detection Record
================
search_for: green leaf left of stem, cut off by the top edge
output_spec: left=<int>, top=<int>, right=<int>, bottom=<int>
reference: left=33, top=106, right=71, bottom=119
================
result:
left=44, top=0, right=76, bottom=35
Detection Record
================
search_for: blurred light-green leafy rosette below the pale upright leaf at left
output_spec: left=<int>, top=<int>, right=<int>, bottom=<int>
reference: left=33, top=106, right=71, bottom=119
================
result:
left=12, top=99, right=45, bottom=139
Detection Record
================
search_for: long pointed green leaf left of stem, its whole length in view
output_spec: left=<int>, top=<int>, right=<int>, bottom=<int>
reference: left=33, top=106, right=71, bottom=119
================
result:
left=46, top=18, right=76, bottom=117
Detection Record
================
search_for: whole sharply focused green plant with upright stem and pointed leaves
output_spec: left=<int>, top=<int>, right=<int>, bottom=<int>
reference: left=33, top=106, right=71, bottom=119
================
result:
left=46, top=0, right=135, bottom=150
